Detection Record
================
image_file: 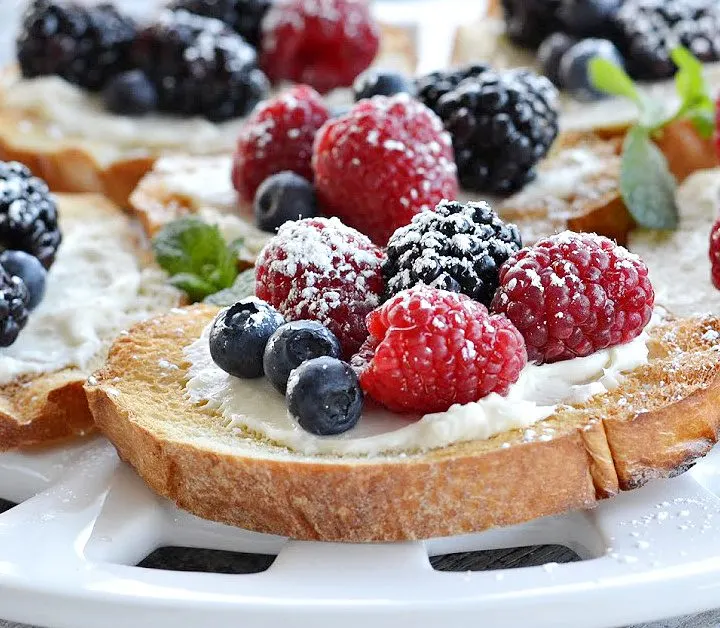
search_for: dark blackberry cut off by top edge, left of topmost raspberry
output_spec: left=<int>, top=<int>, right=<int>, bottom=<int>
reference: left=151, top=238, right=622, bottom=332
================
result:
left=169, top=0, right=272, bottom=48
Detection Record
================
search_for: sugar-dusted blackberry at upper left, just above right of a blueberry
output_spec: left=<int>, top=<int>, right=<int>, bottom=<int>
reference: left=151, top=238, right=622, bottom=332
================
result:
left=133, top=11, right=268, bottom=122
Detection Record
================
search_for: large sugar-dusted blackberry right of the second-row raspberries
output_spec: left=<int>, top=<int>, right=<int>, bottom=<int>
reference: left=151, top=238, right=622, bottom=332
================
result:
left=437, top=69, right=558, bottom=195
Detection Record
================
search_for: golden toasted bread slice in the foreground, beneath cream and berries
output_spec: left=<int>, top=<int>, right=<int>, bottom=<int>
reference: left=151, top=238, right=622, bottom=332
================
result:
left=86, top=306, right=720, bottom=542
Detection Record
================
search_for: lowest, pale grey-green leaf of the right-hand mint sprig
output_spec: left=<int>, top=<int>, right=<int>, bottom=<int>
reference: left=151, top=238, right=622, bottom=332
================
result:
left=620, top=127, right=678, bottom=229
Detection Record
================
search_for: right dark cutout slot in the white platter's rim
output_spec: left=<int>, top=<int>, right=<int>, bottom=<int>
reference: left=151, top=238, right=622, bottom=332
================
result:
left=430, top=545, right=582, bottom=571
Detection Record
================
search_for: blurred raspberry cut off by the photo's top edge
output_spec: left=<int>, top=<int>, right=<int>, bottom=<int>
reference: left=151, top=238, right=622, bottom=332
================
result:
left=260, top=0, right=380, bottom=93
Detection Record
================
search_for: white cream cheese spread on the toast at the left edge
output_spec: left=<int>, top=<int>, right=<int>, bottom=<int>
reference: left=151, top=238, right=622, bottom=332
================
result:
left=0, top=206, right=178, bottom=385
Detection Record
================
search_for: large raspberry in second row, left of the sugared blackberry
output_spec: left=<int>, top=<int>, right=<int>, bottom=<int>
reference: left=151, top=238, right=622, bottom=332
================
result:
left=313, top=94, right=458, bottom=246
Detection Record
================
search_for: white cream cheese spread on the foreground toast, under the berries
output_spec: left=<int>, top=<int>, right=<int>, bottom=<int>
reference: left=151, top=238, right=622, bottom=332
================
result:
left=185, top=326, right=648, bottom=456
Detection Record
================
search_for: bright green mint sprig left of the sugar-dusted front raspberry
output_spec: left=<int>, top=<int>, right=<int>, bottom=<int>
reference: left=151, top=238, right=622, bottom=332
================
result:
left=152, top=216, right=238, bottom=302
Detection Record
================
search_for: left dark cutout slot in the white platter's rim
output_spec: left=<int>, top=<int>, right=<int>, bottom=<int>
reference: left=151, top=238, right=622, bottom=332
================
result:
left=137, top=546, right=276, bottom=574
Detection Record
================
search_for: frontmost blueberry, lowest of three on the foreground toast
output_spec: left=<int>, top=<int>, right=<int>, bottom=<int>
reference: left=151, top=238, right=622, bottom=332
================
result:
left=286, top=356, right=363, bottom=436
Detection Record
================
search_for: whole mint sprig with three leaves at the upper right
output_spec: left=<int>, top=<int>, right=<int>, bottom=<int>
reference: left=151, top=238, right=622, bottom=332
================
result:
left=590, top=47, right=715, bottom=229
